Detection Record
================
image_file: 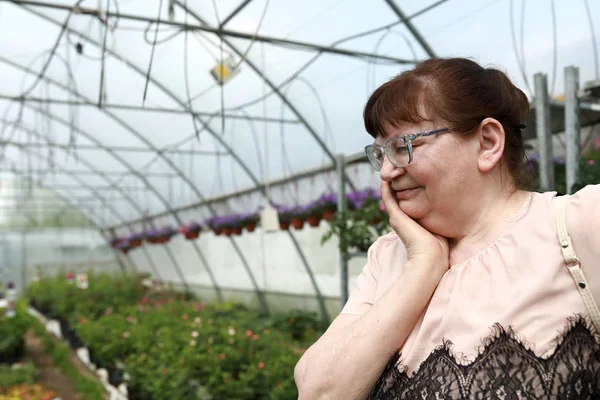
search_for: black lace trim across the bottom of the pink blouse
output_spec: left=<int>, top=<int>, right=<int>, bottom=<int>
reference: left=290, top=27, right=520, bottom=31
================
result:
left=368, top=315, right=600, bottom=400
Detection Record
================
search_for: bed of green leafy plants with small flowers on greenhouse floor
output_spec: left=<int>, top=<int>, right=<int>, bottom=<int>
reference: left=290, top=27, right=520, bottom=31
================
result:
left=27, top=273, right=323, bottom=400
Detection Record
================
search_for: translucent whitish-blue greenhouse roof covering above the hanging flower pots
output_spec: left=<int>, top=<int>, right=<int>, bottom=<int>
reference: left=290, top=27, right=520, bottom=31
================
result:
left=0, top=0, right=600, bottom=225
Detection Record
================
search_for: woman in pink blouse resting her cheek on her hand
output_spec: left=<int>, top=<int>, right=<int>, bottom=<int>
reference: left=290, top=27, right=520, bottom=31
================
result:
left=295, top=59, right=600, bottom=400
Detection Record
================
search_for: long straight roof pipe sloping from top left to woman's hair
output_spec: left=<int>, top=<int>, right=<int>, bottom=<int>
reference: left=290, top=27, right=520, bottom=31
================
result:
left=3, top=0, right=418, bottom=64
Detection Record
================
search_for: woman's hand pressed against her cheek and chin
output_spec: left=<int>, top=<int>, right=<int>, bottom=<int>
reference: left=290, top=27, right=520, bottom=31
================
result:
left=381, top=181, right=450, bottom=272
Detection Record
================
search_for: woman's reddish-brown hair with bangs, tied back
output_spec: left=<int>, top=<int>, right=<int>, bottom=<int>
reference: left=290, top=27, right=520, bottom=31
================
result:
left=363, top=58, right=531, bottom=187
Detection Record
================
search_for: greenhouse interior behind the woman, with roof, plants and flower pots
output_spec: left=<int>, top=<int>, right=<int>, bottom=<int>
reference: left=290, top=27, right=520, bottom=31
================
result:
left=0, top=0, right=600, bottom=400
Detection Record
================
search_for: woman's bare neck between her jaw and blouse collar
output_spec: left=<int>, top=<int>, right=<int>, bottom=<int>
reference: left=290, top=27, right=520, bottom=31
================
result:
left=448, top=184, right=528, bottom=265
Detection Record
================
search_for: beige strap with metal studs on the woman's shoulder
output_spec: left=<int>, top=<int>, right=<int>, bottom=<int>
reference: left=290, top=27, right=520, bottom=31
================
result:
left=554, top=195, right=600, bottom=333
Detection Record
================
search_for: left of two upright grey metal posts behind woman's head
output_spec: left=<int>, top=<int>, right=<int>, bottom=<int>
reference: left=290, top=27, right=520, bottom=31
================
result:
left=534, top=73, right=554, bottom=191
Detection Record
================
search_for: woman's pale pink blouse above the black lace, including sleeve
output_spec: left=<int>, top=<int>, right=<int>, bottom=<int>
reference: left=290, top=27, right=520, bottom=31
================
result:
left=342, top=185, right=600, bottom=398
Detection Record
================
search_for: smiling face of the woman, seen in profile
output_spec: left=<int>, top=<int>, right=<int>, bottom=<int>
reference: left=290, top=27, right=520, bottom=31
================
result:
left=375, top=122, right=479, bottom=236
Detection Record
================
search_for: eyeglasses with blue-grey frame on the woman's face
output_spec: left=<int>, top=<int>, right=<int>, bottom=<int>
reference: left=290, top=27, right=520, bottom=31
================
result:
left=365, top=128, right=451, bottom=171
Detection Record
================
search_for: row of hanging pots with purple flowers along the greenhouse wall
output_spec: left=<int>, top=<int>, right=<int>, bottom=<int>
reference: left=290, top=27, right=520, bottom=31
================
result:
left=111, top=188, right=381, bottom=253
